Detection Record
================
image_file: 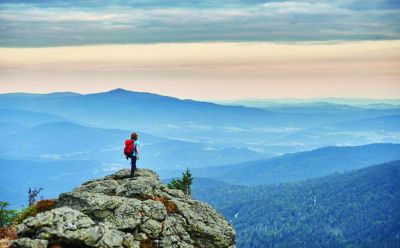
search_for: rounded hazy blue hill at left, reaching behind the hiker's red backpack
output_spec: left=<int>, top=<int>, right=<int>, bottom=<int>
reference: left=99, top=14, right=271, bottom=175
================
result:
left=0, top=122, right=164, bottom=161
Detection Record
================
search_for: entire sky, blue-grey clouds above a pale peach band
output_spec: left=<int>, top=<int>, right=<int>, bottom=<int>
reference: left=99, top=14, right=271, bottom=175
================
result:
left=0, top=0, right=400, bottom=99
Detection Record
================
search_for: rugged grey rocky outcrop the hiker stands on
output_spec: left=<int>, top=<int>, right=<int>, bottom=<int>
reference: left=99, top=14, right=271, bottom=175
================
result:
left=11, top=169, right=235, bottom=248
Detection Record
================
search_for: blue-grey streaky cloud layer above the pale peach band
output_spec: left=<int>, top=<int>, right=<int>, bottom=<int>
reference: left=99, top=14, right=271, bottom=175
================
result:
left=0, top=0, right=400, bottom=47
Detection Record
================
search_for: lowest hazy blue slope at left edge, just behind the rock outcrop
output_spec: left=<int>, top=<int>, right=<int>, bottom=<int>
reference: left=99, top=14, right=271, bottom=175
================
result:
left=0, top=159, right=99, bottom=208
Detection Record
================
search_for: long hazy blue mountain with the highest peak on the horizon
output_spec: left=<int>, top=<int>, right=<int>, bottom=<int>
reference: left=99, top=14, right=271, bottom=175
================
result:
left=0, top=89, right=273, bottom=131
